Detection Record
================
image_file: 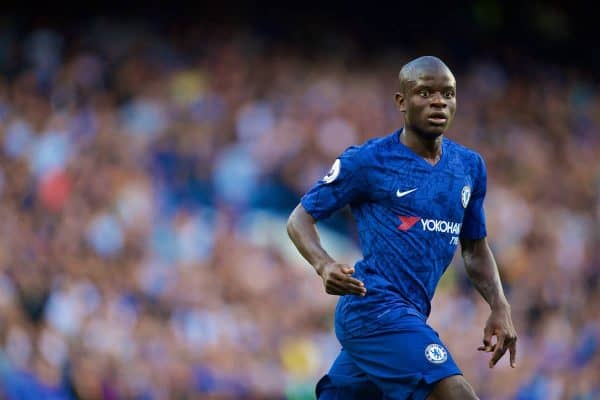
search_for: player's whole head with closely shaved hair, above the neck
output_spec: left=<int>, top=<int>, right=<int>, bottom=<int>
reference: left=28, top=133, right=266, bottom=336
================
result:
left=395, top=56, right=456, bottom=139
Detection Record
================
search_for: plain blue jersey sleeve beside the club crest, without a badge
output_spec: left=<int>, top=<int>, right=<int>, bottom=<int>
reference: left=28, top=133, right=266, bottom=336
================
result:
left=460, top=155, right=487, bottom=240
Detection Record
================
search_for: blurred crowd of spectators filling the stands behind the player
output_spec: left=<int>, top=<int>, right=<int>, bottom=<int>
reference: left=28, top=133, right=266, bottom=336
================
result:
left=0, top=24, right=600, bottom=400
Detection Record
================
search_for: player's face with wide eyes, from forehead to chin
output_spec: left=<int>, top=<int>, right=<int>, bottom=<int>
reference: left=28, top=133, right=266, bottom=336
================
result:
left=396, top=69, right=456, bottom=139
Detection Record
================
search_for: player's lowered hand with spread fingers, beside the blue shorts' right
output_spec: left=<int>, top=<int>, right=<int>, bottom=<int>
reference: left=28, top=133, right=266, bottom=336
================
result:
left=477, top=308, right=517, bottom=368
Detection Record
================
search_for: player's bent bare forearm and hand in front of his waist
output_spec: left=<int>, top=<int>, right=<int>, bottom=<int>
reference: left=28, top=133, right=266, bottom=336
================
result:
left=287, top=204, right=366, bottom=296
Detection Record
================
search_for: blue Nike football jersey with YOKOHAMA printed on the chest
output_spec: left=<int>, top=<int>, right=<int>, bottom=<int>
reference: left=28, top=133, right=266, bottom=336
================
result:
left=301, top=130, right=487, bottom=336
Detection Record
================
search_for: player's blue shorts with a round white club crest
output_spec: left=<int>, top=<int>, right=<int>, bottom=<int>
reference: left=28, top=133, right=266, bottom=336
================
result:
left=316, top=315, right=462, bottom=400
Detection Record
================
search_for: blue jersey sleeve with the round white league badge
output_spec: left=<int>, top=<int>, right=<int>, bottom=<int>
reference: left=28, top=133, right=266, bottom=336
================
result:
left=300, top=147, right=367, bottom=220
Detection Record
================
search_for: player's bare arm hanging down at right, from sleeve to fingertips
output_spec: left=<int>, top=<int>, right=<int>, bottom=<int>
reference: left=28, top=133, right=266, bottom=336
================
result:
left=460, top=238, right=517, bottom=368
